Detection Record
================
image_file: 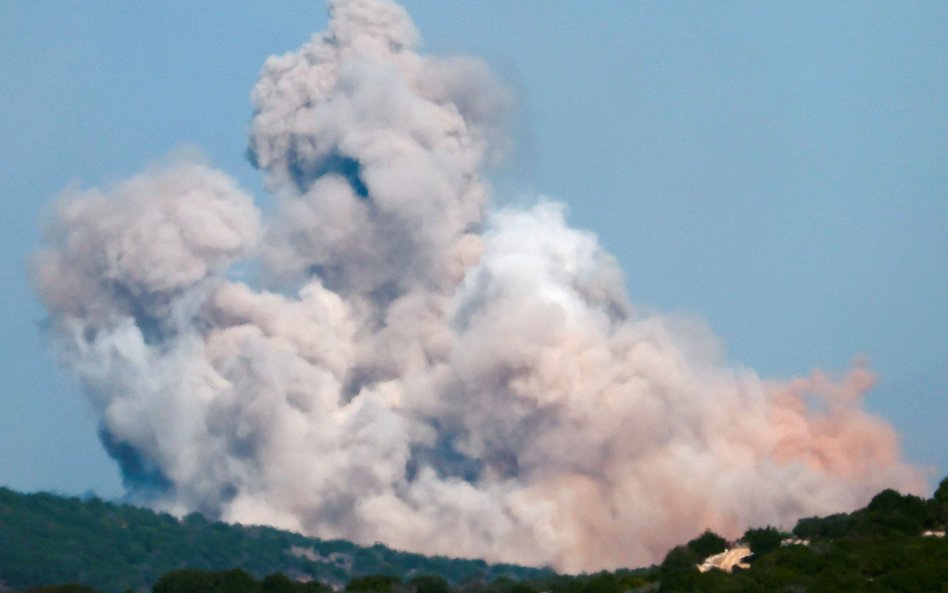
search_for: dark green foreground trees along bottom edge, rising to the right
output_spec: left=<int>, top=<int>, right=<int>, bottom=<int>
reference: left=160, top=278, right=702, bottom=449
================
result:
left=0, top=478, right=948, bottom=593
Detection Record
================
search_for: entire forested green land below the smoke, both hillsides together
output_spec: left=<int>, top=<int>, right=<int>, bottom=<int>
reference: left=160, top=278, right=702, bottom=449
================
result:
left=0, top=478, right=948, bottom=593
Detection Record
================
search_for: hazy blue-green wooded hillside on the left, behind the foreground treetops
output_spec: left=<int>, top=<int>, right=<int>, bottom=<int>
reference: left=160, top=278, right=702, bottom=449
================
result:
left=0, top=488, right=549, bottom=593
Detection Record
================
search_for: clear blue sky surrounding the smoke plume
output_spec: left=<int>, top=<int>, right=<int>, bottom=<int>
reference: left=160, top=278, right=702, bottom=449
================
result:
left=0, top=0, right=948, bottom=496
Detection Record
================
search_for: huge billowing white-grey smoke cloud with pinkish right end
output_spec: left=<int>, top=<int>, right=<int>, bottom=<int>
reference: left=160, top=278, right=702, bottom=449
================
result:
left=34, top=0, right=923, bottom=570
